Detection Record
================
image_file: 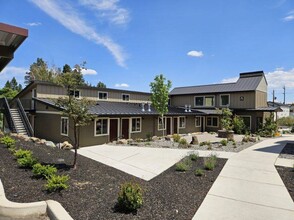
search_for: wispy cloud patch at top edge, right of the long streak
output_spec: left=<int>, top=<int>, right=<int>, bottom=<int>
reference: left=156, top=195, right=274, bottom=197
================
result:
left=79, top=0, right=130, bottom=25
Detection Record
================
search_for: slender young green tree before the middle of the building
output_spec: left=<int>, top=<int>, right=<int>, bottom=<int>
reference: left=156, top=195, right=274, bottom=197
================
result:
left=150, top=74, right=172, bottom=136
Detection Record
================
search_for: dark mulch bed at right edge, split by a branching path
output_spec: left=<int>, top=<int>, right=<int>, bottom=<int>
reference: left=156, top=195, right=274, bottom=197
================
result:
left=276, top=143, right=294, bottom=201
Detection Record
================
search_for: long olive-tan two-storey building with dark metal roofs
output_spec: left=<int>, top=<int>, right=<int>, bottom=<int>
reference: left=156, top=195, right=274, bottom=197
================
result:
left=0, top=72, right=277, bottom=146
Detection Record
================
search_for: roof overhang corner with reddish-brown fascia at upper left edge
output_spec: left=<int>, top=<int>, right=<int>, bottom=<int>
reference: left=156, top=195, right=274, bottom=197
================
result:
left=0, top=23, right=28, bottom=72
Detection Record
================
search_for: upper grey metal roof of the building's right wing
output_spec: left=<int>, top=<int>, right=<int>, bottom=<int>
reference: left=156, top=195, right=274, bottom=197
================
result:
left=170, top=71, right=264, bottom=95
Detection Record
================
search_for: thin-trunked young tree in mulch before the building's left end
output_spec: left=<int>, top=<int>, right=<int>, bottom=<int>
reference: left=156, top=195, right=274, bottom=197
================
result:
left=56, top=67, right=93, bottom=169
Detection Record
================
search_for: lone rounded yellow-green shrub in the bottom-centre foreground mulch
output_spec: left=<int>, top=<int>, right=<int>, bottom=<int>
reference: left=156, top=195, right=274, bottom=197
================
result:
left=117, top=182, right=143, bottom=211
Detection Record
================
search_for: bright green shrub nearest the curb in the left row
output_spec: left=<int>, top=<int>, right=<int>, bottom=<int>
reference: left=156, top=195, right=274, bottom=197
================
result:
left=45, top=175, right=69, bottom=192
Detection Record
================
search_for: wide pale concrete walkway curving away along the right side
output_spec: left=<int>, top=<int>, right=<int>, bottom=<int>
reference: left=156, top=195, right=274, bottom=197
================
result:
left=193, top=135, right=294, bottom=220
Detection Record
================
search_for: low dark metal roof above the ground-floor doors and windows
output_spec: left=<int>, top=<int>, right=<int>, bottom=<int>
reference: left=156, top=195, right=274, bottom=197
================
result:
left=34, top=98, right=208, bottom=116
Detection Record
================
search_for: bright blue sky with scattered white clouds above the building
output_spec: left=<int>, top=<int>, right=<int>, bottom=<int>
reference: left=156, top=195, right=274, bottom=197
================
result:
left=0, top=0, right=294, bottom=102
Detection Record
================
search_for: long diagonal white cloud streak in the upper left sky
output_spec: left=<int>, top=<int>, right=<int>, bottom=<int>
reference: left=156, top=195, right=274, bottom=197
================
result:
left=31, top=0, right=126, bottom=67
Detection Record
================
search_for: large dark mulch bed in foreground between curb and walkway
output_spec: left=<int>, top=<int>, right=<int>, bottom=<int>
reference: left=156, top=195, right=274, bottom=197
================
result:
left=0, top=137, right=226, bottom=220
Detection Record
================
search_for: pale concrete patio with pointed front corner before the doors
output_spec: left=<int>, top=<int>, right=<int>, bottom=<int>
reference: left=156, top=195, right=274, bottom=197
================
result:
left=78, top=145, right=236, bottom=181
